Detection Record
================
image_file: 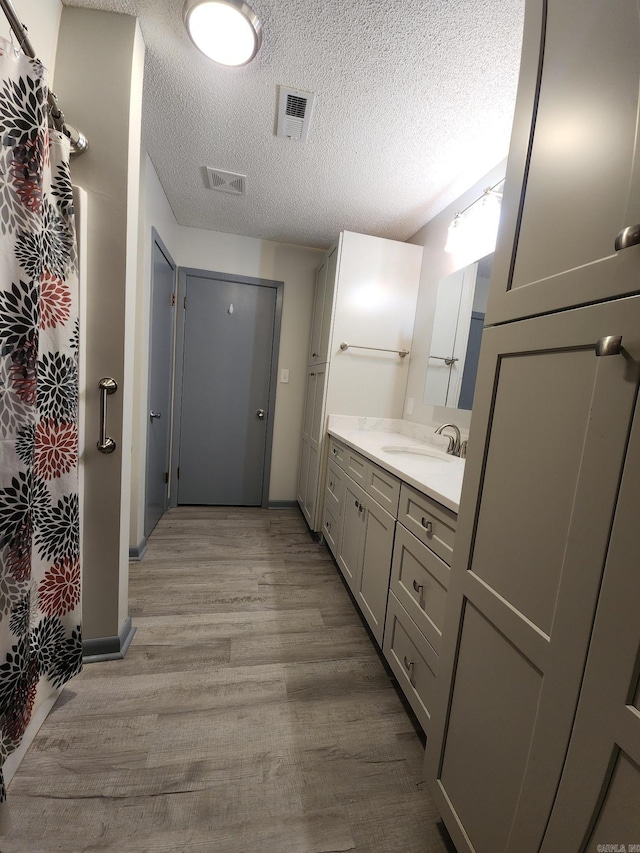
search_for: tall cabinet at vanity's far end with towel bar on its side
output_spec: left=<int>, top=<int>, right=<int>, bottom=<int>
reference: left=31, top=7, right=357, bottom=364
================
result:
left=297, top=231, right=422, bottom=531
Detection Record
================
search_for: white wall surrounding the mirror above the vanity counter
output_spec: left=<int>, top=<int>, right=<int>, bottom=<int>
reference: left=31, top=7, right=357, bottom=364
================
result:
left=404, top=161, right=506, bottom=432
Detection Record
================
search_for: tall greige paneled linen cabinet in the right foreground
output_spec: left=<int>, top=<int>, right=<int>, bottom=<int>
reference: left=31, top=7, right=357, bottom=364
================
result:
left=425, top=0, right=640, bottom=853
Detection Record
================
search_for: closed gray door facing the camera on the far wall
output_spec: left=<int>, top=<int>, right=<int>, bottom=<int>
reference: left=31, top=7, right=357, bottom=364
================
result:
left=178, top=273, right=277, bottom=506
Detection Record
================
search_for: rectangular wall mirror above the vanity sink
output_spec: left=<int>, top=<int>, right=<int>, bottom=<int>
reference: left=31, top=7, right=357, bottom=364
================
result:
left=424, top=254, right=493, bottom=409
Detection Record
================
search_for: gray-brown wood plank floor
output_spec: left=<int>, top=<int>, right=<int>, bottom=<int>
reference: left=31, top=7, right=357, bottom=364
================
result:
left=5, top=507, right=453, bottom=853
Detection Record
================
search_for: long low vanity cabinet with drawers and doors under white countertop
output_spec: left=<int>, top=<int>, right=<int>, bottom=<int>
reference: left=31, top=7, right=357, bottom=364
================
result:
left=323, top=436, right=456, bottom=732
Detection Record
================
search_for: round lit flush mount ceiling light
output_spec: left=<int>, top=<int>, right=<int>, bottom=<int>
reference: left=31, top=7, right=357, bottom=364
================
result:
left=182, top=0, right=262, bottom=66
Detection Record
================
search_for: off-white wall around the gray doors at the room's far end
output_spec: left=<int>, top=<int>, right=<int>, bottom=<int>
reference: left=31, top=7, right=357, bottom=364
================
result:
left=130, top=156, right=324, bottom=548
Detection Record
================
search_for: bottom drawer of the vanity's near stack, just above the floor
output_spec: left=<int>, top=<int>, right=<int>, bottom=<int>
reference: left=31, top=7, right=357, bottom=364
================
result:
left=383, top=592, right=438, bottom=736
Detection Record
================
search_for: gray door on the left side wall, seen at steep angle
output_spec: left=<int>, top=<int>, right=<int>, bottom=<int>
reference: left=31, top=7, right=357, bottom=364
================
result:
left=144, top=231, right=176, bottom=536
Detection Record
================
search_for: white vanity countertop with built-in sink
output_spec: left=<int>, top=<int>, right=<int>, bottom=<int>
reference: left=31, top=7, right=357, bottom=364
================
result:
left=328, top=421, right=465, bottom=513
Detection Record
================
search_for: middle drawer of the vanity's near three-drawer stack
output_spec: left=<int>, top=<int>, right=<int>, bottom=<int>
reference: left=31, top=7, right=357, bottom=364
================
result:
left=391, top=523, right=450, bottom=652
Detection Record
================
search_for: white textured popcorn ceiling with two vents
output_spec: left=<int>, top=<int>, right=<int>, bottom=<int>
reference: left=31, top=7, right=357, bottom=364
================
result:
left=63, top=0, right=524, bottom=247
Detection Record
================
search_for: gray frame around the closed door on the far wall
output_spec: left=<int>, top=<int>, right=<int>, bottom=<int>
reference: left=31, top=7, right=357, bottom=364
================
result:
left=169, top=267, right=284, bottom=509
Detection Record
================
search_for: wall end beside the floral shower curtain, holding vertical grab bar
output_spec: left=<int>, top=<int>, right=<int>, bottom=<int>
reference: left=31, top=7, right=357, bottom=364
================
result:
left=55, top=6, right=144, bottom=641
